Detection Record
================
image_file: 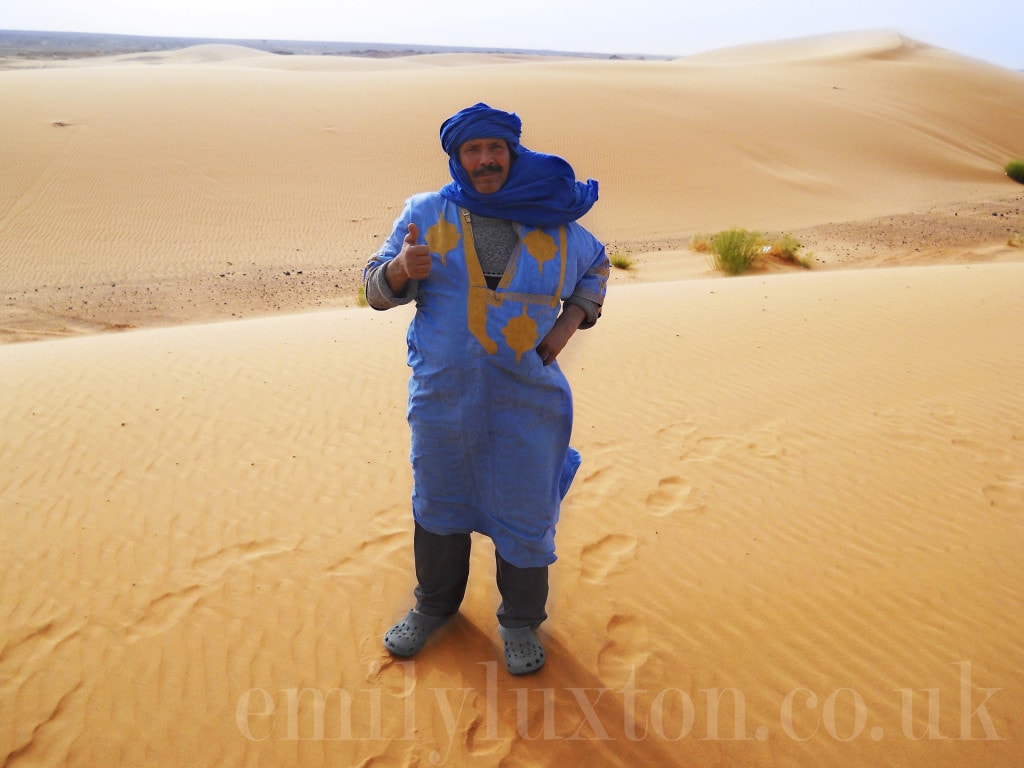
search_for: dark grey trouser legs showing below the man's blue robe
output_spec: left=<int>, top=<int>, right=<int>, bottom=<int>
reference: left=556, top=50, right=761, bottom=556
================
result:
left=413, top=523, right=548, bottom=629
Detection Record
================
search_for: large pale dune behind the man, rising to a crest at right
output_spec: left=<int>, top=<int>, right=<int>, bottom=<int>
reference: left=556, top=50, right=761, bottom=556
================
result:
left=0, top=33, right=1024, bottom=338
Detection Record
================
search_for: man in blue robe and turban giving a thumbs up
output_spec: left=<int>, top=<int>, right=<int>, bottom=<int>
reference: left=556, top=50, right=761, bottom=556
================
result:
left=364, top=103, right=608, bottom=675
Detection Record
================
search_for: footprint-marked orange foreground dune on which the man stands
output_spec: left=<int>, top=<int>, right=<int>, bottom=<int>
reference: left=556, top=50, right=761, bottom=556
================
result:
left=0, top=264, right=1024, bottom=765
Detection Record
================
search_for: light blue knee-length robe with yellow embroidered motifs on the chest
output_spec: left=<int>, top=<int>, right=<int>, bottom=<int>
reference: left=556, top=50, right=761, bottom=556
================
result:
left=369, top=193, right=608, bottom=567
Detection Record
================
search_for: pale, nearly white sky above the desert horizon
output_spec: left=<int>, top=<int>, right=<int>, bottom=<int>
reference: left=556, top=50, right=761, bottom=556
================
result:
left=0, top=0, right=1024, bottom=69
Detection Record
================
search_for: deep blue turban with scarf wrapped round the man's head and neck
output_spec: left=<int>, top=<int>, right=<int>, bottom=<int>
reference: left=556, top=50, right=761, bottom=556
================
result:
left=440, top=103, right=597, bottom=226
